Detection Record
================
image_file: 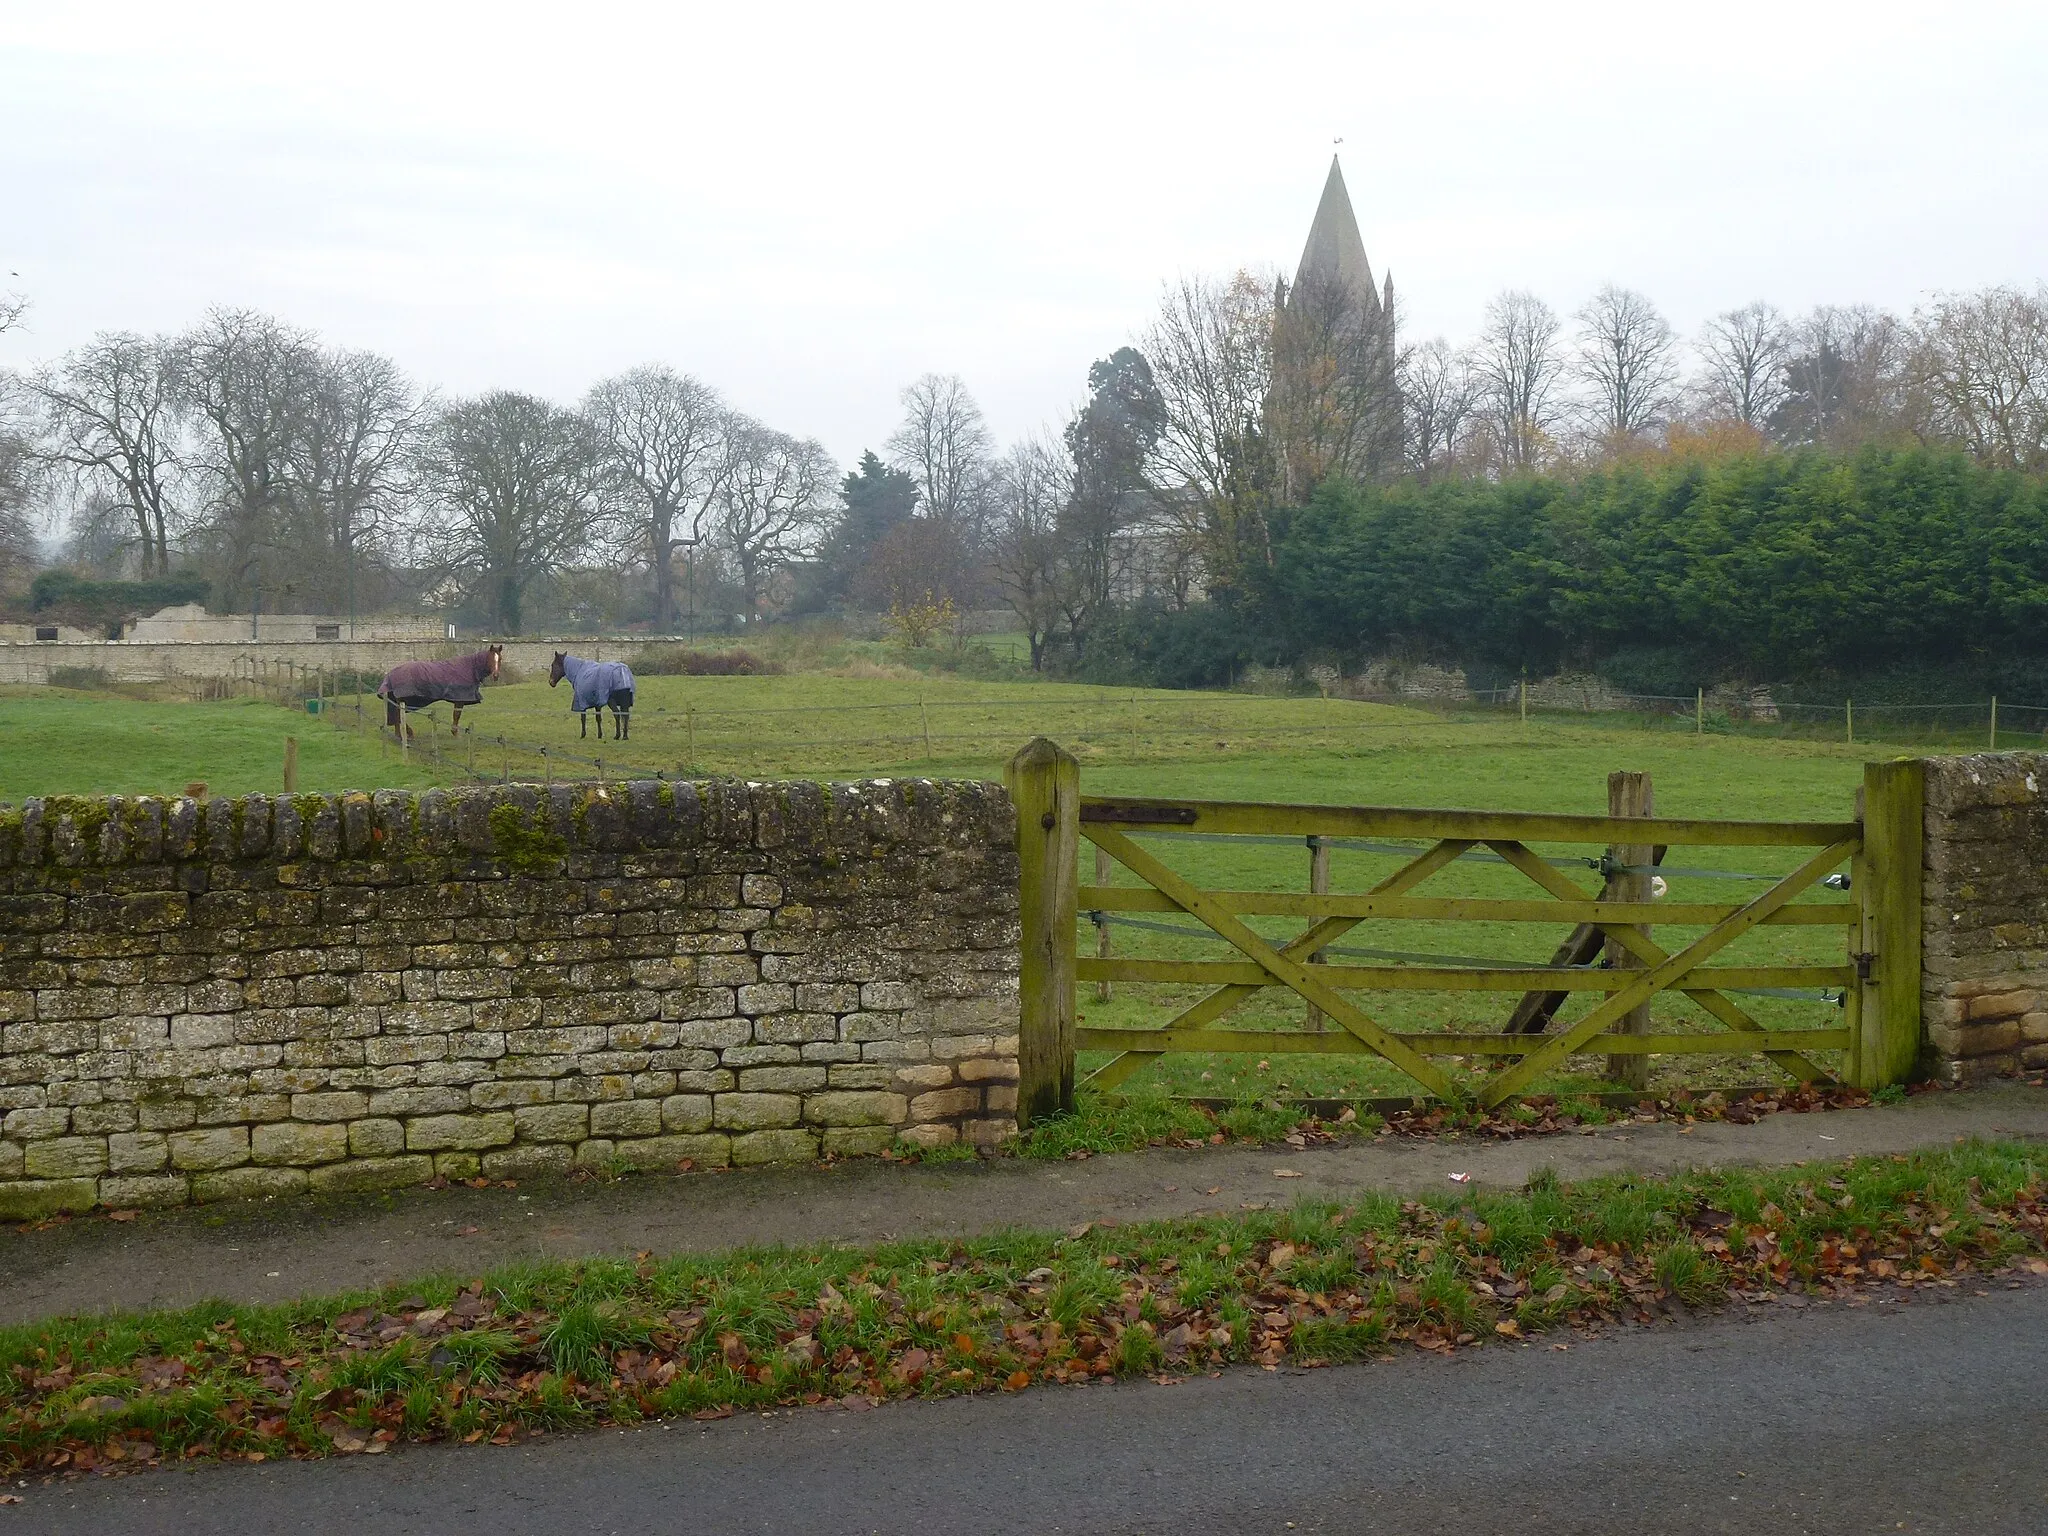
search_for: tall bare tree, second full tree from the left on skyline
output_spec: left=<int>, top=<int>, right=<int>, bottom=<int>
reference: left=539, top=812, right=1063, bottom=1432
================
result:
left=178, top=309, right=319, bottom=606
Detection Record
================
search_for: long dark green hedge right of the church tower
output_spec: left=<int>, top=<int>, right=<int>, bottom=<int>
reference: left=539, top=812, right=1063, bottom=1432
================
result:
left=1260, top=451, right=2048, bottom=692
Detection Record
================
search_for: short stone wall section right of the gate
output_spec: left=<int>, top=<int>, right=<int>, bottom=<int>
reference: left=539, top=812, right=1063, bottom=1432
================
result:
left=1921, top=752, right=2048, bottom=1083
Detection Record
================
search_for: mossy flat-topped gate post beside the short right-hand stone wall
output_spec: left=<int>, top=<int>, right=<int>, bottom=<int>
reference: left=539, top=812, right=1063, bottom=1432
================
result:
left=1849, top=760, right=1927, bottom=1087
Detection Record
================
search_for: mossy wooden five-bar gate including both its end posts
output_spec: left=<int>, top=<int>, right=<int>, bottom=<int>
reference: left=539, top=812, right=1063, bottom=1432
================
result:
left=1006, top=737, right=1921, bottom=1124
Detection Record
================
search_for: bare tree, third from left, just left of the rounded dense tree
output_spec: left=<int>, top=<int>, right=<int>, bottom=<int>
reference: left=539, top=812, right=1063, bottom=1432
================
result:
left=291, top=352, right=432, bottom=614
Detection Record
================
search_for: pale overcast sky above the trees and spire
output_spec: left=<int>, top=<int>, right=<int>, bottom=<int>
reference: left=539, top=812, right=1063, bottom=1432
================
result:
left=0, top=0, right=2048, bottom=459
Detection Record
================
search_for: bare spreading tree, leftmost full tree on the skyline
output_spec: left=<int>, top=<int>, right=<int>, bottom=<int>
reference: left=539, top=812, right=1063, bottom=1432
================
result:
left=29, top=332, right=184, bottom=575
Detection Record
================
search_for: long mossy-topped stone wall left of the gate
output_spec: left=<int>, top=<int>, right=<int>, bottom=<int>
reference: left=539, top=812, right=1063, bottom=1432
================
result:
left=0, top=780, right=1018, bottom=1217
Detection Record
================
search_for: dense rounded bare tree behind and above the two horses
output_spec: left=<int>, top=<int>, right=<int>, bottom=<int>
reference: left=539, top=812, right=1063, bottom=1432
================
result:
left=420, top=399, right=606, bottom=635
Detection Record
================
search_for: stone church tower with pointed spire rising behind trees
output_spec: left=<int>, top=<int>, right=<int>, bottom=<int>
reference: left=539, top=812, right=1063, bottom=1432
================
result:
left=1268, top=156, right=1401, bottom=502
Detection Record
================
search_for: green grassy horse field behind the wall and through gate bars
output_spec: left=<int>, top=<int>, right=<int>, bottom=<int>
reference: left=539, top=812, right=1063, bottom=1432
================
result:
left=0, top=659, right=1878, bottom=1100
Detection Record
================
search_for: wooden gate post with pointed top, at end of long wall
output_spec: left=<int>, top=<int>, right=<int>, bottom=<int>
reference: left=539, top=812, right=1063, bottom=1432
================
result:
left=1004, top=735, right=1081, bottom=1128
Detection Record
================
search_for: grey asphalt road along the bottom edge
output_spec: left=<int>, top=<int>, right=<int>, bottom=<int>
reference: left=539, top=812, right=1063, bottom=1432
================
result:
left=16, top=1286, right=2048, bottom=1536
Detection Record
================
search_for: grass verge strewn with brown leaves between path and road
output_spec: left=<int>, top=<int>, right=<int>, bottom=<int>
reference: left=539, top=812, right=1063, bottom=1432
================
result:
left=0, top=1141, right=2048, bottom=1477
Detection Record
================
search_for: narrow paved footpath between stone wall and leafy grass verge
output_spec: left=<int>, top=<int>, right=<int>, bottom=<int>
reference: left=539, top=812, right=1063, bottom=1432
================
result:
left=0, top=1085, right=2048, bottom=1323
